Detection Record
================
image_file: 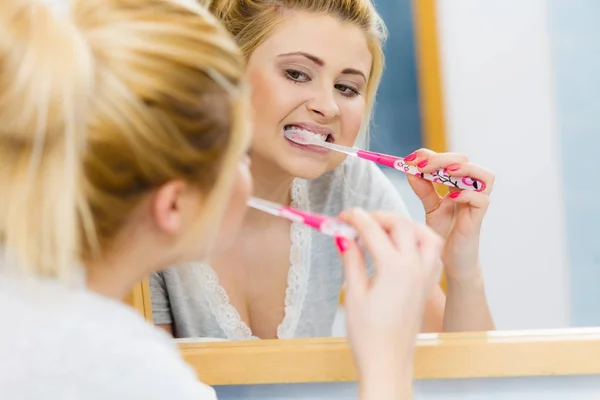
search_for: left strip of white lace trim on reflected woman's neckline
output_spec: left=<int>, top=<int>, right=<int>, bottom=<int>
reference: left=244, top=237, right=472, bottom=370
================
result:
left=191, top=264, right=259, bottom=340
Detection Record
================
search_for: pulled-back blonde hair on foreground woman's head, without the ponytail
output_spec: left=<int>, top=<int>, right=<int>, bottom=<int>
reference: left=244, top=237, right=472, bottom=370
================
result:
left=73, top=0, right=246, bottom=259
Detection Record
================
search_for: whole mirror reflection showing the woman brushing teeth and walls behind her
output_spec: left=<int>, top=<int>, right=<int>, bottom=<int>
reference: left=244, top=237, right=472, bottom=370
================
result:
left=151, top=0, right=600, bottom=340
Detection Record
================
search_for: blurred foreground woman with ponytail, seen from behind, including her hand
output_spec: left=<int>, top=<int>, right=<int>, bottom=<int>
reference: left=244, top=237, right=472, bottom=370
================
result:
left=0, top=0, right=441, bottom=400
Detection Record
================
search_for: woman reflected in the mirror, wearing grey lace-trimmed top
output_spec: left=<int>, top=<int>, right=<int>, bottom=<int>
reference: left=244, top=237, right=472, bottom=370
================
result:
left=151, top=0, right=494, bottom=340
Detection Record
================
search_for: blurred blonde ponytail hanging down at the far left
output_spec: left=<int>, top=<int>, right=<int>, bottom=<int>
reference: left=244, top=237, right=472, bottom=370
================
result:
left=0, top=0, right=93, bottom=277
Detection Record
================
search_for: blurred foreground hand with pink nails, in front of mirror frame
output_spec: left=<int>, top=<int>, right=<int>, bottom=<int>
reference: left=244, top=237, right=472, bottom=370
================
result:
left=336, top=209, right=443, bottom=400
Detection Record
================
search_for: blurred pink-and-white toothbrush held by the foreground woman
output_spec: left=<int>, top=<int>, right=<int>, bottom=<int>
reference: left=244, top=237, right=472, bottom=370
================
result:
left=248, top=197, right=358, bottom=240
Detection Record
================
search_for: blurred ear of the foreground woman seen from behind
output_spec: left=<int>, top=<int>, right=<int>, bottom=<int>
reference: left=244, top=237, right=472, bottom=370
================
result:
left=150, top=181, right=189, bottom=234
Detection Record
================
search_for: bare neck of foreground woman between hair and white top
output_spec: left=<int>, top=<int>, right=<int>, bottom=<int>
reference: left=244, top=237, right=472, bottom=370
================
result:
left=86, top=245, right=155, bottom=300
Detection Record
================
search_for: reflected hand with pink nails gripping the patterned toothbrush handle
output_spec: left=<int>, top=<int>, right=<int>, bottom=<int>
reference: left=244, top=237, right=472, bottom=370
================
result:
left=405, top=149, right=494, bottom=280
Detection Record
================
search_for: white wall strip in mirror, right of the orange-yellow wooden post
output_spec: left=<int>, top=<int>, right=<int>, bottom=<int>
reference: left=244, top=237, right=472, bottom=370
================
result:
left=438, top=0, right=570, bottom=329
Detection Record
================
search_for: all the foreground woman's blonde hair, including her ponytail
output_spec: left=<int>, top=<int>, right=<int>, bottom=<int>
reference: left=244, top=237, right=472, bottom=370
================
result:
left=0, top=0, right=246, bottom=278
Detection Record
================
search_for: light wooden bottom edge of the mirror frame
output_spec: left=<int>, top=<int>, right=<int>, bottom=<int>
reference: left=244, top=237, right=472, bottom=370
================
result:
left=179, top=329, right=600, bottom=385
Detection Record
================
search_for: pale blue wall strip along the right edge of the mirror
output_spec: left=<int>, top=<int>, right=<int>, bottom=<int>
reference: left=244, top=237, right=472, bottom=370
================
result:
left=552, top=0, right=600, bottom=326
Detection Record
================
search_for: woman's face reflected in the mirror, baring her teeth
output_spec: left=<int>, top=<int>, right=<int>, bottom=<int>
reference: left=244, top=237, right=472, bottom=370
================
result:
left=248, top=12, right=372, bottom=179
